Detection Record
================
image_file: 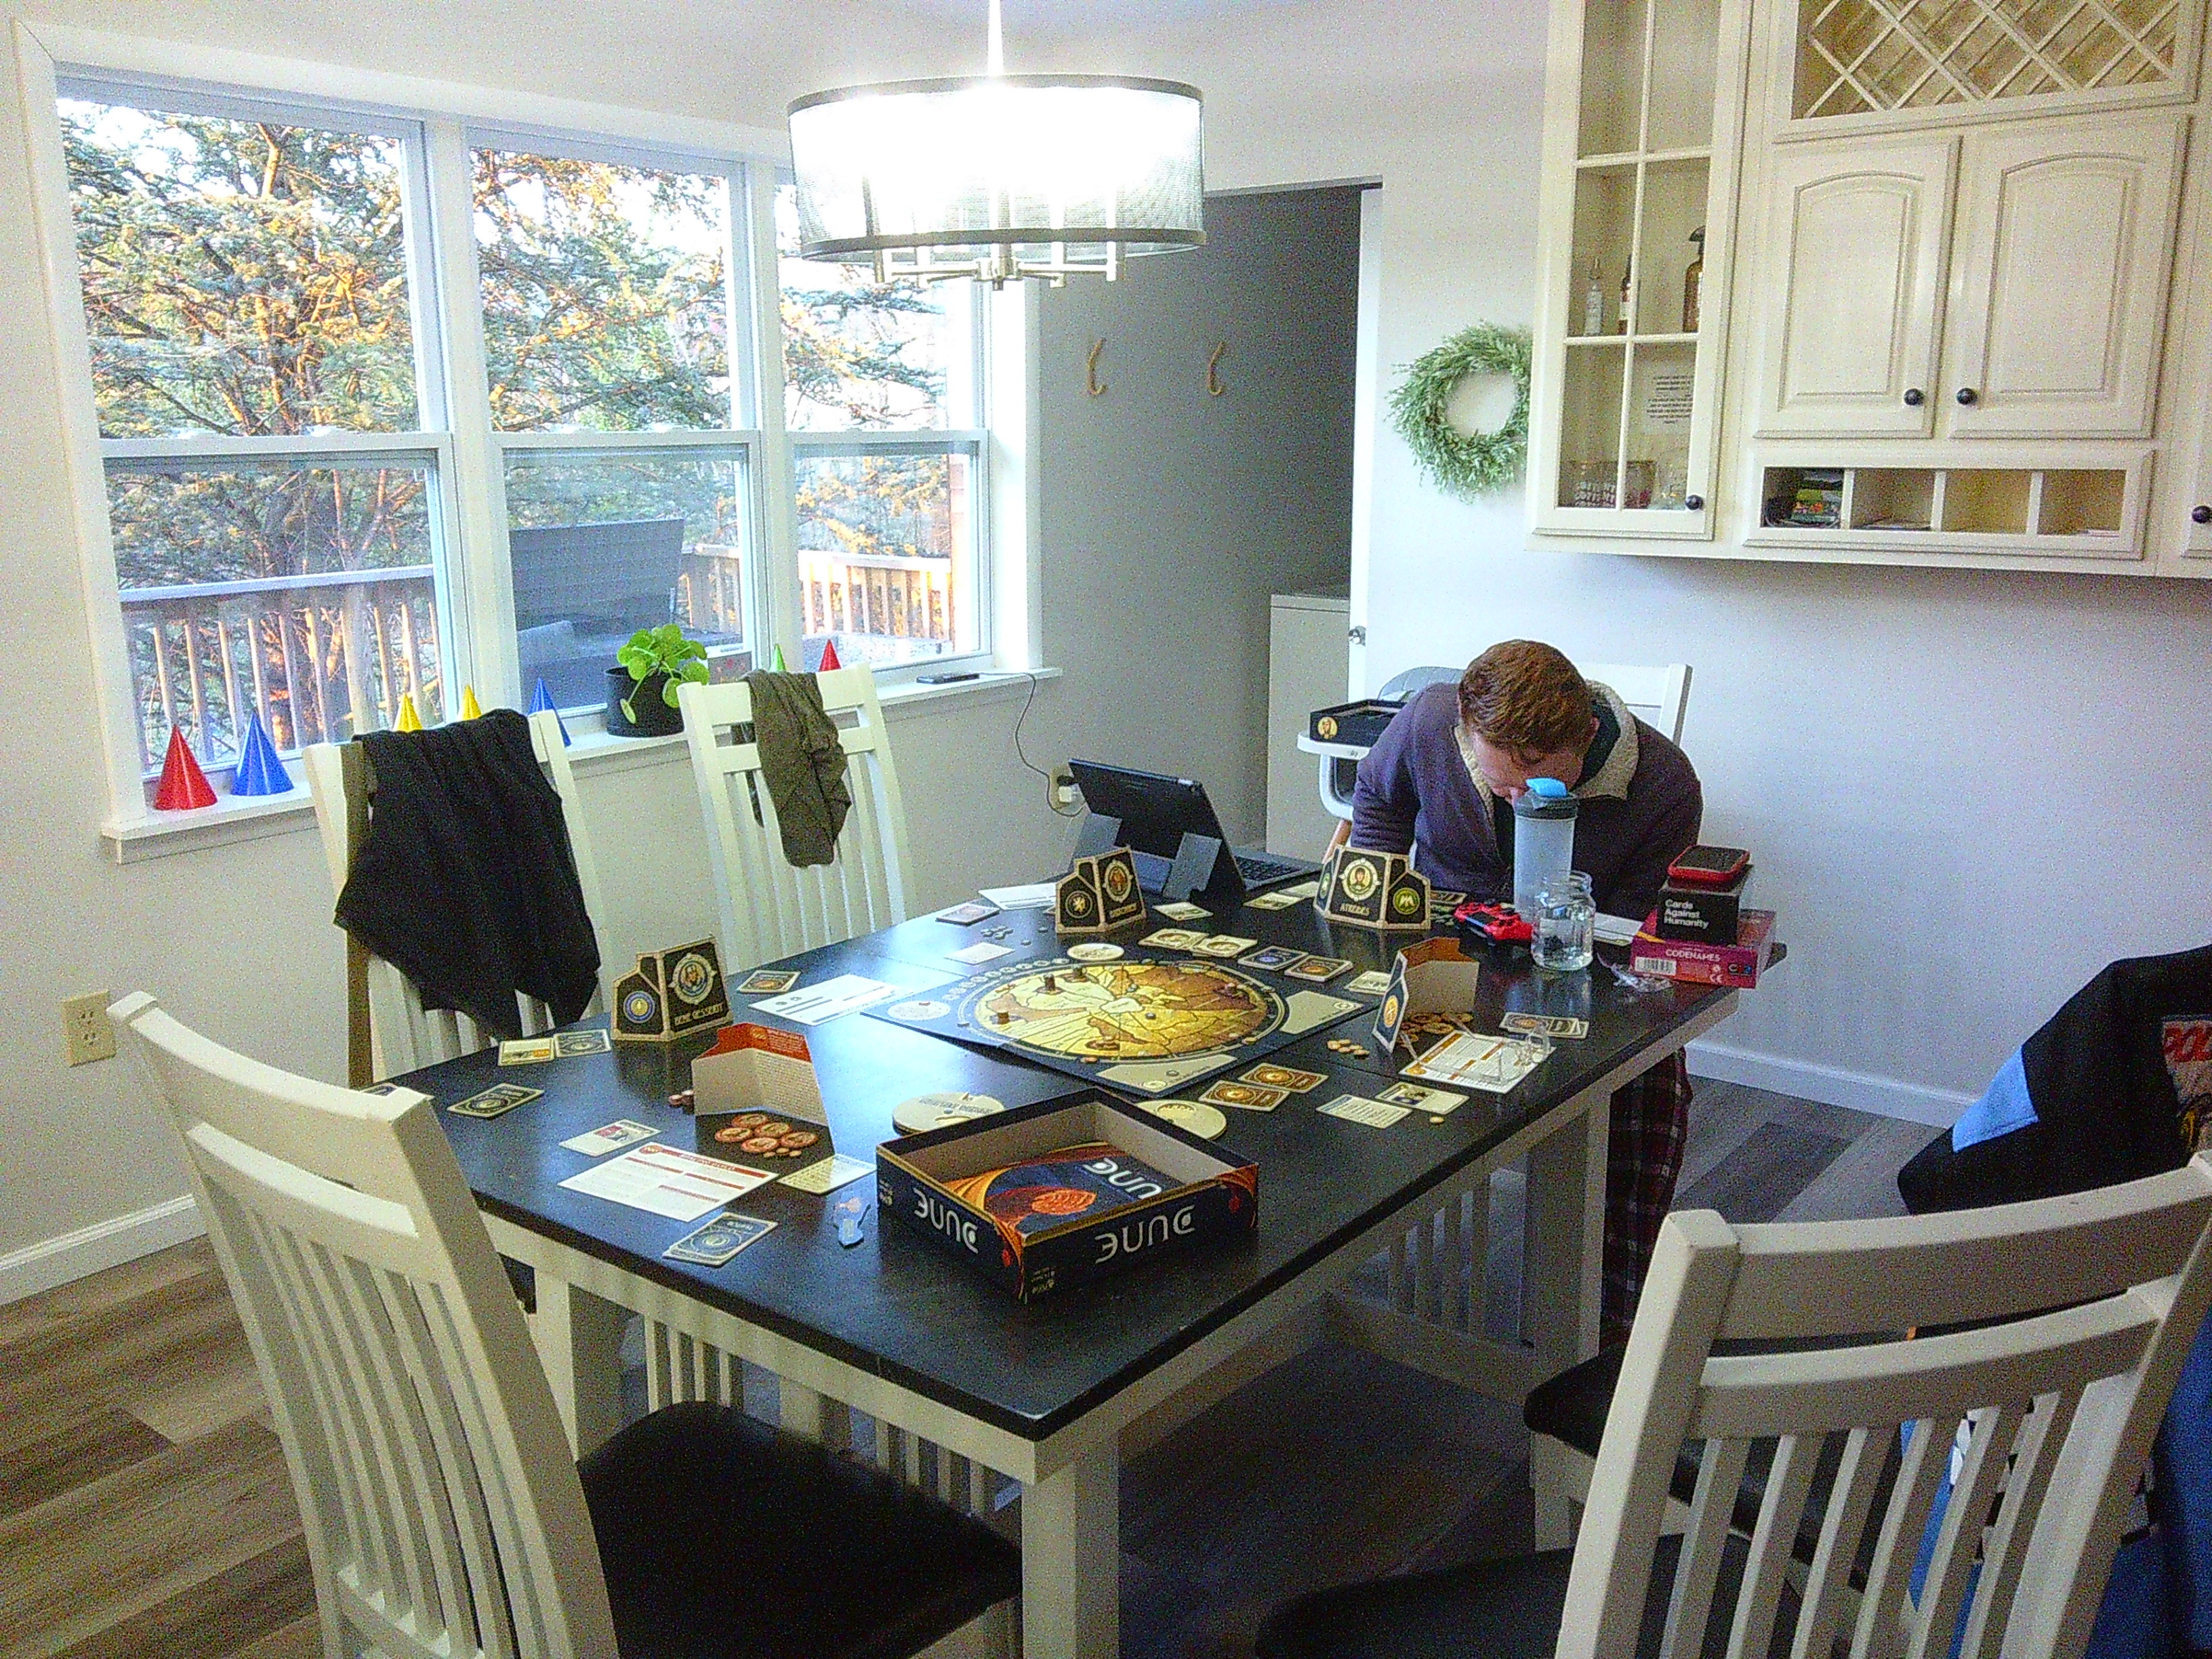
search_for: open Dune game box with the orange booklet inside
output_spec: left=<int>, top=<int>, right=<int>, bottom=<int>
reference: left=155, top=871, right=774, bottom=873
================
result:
left=876, top=1095, right=1258, bottom=1303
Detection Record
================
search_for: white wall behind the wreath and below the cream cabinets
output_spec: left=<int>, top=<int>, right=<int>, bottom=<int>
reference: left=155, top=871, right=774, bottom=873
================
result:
left=1011, top=0, right=2212, bottom=1122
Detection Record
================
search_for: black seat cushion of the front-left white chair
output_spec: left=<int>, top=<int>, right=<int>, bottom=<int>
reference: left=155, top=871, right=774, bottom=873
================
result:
left=577, top=1402, right=1022, bottom=1659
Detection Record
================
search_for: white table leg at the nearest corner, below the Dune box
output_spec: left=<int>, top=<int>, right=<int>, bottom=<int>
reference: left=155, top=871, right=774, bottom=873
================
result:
left=1022, top=1438, right=1122, bottom=1659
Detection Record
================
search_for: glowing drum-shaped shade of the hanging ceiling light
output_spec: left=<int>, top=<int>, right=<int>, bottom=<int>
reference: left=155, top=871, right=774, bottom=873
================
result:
left=790, top=75, right=1206, bottom=281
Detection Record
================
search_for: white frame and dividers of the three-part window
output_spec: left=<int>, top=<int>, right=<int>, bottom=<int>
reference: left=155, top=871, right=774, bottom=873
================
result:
left=14, top=20, right=1038, bottom=849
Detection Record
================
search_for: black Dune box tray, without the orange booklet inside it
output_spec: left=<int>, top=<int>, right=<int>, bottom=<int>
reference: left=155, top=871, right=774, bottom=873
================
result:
left=876, top=1095, right=1258, bottom=1303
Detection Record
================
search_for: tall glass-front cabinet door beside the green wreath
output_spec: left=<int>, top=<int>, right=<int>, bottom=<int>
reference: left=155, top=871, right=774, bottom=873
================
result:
left=1528, top=0, right=1748, bottom=539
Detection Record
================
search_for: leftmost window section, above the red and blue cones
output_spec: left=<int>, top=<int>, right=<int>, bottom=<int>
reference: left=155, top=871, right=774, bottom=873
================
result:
left=60, top=95, right=449, bottom=772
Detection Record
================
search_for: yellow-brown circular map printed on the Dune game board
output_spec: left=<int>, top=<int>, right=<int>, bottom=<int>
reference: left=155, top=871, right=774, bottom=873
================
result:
left=960, top=958, right=1283, bottom=1059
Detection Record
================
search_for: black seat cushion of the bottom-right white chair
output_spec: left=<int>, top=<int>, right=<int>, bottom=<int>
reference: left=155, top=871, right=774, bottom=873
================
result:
left=1254, top=1535, right=1796, bottom=1659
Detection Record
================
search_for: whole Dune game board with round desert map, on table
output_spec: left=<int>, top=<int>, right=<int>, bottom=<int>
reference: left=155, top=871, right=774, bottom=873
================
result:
left=872, top=951, right=1363, bottom=1095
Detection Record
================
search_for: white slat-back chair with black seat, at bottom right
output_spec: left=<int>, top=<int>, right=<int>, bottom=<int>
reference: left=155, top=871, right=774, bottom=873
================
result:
left=1258, top=1157, right=2212, bottom=1659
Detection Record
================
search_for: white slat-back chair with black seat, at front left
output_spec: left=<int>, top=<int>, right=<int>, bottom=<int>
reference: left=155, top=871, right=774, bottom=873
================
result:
left=110, top=996, right=1020, bottom=1659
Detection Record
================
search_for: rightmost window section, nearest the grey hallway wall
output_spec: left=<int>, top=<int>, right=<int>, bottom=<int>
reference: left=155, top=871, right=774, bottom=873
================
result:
left=777, top=184, right=989, bottom=665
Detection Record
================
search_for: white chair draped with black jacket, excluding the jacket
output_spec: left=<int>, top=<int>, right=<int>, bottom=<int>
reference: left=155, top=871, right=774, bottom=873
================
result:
left=301, top=710, right=609, bottom=1088
